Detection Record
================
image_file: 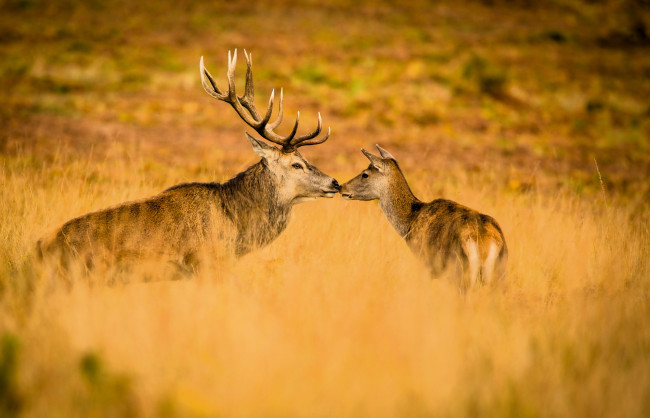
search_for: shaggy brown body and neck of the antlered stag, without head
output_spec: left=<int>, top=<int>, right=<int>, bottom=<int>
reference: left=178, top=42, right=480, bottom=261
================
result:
left=39, top=158, right=284, bottom=267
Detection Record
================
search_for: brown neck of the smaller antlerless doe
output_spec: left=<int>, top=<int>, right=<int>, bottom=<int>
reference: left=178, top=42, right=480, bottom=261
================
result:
left=379, top=172, right=420, bottom=237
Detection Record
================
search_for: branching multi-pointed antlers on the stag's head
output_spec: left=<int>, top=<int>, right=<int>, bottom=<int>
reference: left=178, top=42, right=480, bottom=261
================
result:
left=199, top=49, right=331, bottom=152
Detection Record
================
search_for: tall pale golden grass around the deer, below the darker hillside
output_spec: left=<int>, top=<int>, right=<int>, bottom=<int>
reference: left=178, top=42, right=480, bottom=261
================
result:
left=0, top=151, right=650, bottom=417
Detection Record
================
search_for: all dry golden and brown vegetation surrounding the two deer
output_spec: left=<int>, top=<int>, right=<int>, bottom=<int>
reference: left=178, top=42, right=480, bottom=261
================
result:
left=0, top=0, right=650, bottom=417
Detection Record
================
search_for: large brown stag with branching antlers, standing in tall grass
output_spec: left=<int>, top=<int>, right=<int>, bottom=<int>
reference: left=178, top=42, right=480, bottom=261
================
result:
left=37, top=49, right=340, bottom=280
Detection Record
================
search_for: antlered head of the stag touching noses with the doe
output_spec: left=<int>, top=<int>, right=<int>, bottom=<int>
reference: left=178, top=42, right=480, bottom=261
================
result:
left=200, top=49, right=341, bottom=204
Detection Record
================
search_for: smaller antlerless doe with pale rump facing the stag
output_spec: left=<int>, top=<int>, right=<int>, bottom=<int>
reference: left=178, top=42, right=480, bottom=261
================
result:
left=340, top=145, right=508, bottom=292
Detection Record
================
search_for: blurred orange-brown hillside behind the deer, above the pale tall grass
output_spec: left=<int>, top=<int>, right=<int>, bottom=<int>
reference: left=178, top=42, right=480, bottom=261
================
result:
left=0, top=0, right=650, bottom=198
